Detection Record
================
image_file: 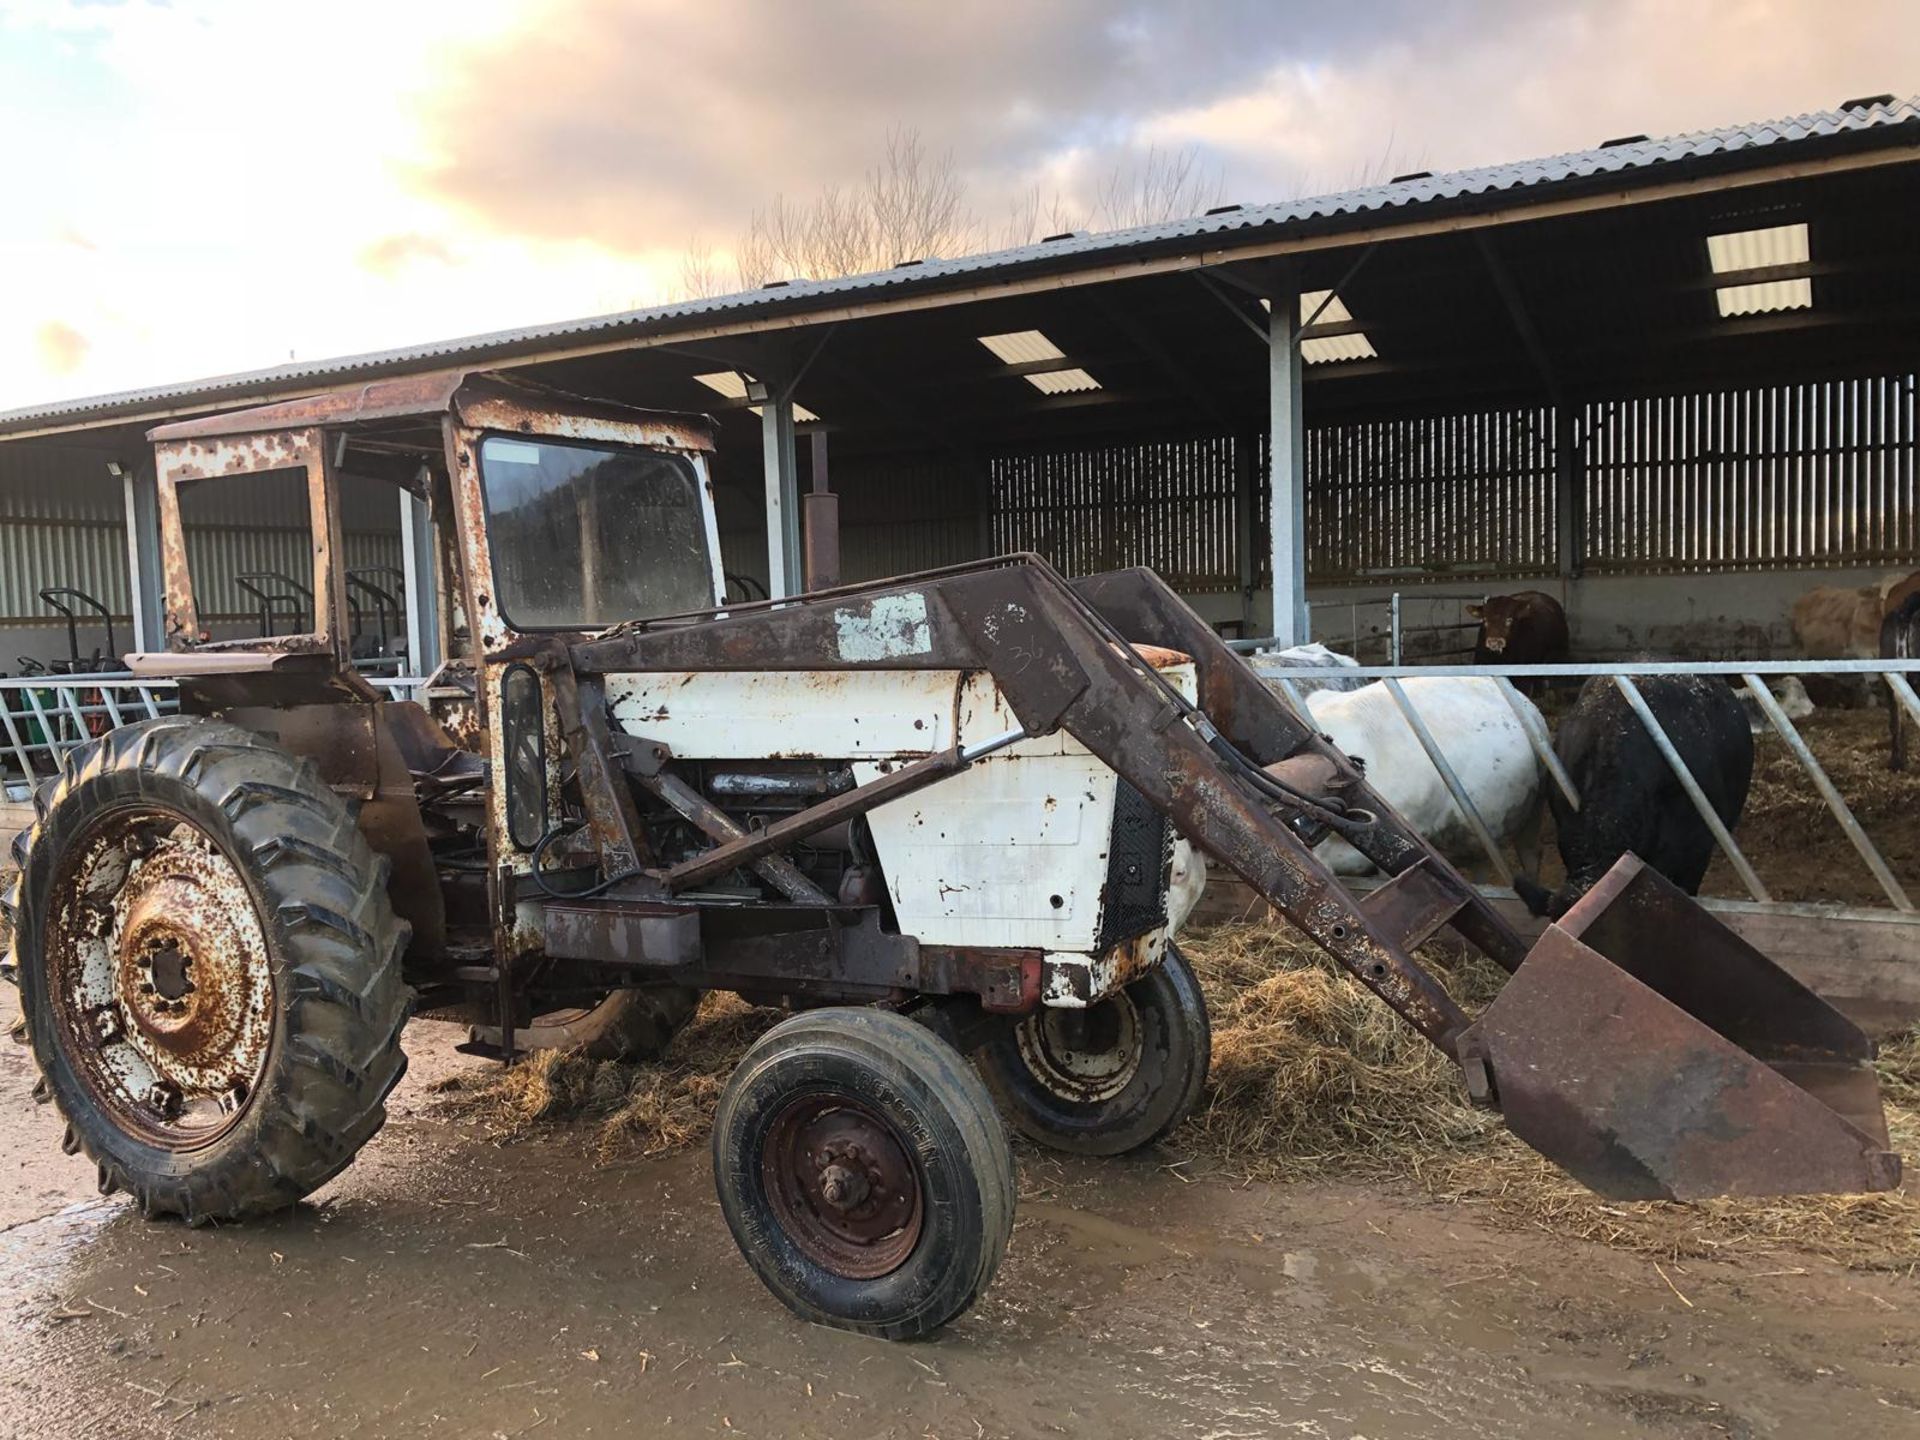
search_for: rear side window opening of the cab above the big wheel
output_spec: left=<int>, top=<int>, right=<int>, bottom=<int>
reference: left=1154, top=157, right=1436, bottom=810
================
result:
left=177, top=468, right=317, bottom=641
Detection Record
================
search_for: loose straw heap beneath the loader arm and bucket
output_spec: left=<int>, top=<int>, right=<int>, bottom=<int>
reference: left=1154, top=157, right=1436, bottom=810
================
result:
left=1177, top=925, right=1920, bottom=1269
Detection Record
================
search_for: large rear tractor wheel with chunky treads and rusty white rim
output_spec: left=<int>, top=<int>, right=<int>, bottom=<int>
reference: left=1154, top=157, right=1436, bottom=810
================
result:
left=12, top=718, right=409, bottom=1223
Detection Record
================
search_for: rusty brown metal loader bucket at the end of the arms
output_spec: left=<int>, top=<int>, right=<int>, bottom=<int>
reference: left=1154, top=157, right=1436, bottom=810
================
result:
left=1459, top=856, right=1901, bottom=1200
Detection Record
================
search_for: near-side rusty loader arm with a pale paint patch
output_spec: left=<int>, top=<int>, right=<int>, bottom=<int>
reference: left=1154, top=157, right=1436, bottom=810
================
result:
left=574, top=559, right=1471, bottom=1054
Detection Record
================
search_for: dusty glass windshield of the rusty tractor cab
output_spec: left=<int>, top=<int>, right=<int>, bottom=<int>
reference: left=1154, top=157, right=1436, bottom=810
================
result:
left=480, top=436, right=714, bottom=630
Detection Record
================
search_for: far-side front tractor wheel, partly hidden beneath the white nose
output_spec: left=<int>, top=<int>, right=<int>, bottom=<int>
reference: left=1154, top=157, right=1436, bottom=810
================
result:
left=973, top=945, right=1213, bottom=1156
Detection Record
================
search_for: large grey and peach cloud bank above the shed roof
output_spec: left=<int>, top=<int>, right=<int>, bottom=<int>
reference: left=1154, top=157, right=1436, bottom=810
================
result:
left=415, top=0, right=1920, bottom=264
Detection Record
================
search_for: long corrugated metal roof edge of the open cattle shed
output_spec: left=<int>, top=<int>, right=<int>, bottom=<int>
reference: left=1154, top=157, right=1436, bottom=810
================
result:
left=0, top=96, right=1920, bottom=434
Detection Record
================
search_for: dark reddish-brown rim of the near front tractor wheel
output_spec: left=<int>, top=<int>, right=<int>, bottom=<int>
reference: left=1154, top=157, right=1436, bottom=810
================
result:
left=762, top=1092, right=922, bottom=1281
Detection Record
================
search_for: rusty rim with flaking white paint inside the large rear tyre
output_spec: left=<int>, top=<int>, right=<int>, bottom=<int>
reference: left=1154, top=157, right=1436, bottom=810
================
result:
left=46, top=806, right=275, bottom=1150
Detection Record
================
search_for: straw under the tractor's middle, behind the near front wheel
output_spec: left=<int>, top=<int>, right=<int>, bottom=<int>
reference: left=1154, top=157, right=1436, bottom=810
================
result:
left=464, top=993, right=780, bottom=1162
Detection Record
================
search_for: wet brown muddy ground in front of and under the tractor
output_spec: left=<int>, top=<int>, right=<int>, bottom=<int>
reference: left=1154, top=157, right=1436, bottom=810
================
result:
left=0, top=989, right=1920, bottom=1440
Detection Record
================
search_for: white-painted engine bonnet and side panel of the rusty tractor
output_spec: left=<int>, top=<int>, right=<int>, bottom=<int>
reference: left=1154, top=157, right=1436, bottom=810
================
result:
left=605, top=662, right=1204, bottom=1004
